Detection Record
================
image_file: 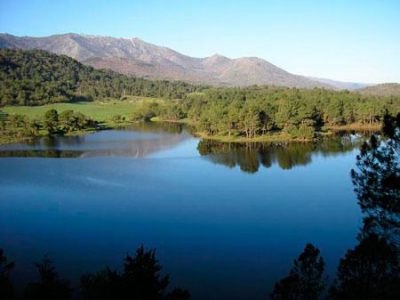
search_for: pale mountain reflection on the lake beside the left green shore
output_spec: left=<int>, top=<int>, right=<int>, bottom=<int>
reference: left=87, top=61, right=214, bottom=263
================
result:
left=0, top=123, right=191, bottom=158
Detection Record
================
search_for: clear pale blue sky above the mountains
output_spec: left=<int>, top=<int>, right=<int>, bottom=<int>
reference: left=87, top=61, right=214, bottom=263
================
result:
left=0, top=0, right=400, bottom=83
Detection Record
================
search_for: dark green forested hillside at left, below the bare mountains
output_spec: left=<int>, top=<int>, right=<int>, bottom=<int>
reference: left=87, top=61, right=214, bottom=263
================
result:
left=0, top=49, right=202, bottom=105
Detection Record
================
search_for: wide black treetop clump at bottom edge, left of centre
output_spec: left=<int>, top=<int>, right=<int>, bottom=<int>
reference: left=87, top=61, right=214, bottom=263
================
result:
left=81, top=246, right=190, bottom=300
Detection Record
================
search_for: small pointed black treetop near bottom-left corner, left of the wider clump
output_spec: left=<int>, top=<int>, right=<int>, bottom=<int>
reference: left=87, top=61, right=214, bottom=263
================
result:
left=24, top=256, right=72, bottom=300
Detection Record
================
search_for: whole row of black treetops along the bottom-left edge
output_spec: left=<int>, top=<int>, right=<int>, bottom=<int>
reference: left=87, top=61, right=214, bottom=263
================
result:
left=0, top=246, right=190, bottom=300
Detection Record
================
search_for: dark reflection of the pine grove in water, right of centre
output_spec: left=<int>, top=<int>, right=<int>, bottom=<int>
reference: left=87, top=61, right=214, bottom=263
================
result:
left=197, top=135, right=359, bottom=173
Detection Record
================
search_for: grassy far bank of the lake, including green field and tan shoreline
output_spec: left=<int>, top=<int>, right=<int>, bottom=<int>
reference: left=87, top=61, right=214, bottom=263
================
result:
left=0, top=97, right=381, bottom=145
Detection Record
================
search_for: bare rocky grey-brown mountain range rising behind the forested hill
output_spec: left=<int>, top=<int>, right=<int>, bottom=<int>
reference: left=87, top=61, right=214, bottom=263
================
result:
left=0, top=33, right=332, bottom=88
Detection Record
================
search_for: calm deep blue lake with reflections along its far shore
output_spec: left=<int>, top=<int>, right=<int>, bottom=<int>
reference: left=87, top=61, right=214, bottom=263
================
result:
left=0, top=124, right=362, bottom=300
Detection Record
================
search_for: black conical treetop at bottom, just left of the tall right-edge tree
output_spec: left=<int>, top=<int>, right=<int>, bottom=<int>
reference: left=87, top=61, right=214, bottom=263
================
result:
left=270, top=244, right=325, bottom=300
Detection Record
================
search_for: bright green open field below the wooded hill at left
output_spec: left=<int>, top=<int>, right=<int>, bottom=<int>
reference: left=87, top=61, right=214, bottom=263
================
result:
left=1, top=97, right=163, bottom=125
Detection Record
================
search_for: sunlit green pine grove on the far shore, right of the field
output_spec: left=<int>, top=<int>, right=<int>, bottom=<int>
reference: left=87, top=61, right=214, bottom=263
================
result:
left=166, top=86, right=400, bottom=140
